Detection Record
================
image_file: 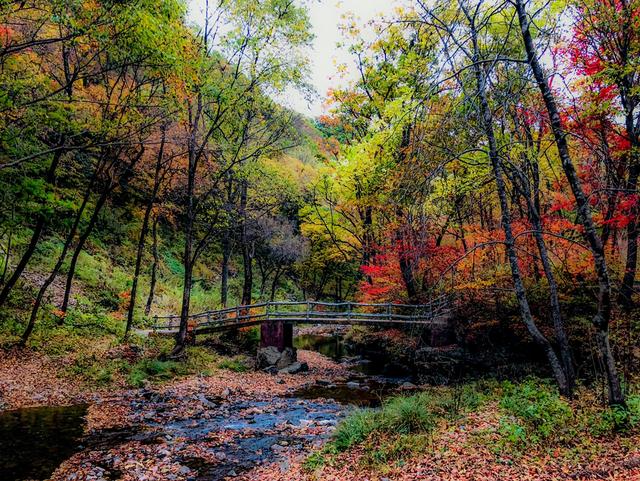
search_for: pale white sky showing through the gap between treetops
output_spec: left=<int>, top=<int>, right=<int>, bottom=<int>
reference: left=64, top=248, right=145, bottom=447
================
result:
left=189, top=0, right=400, bottom=117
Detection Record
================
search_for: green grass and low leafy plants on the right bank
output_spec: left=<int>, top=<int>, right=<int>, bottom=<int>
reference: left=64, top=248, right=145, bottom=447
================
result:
left=305, top=378, right=640, bottom=471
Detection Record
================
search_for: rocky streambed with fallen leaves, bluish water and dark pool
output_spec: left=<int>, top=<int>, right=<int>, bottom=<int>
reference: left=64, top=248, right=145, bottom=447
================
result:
left=0, top=338, right=411, bottom=481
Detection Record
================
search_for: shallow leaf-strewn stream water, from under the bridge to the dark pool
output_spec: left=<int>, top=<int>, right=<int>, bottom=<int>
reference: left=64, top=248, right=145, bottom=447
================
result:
left=0, top=334, right=408, bottom=481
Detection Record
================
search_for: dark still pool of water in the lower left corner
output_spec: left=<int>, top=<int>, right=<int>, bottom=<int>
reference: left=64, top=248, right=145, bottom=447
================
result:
left=0, top=405, right=87, bottom=481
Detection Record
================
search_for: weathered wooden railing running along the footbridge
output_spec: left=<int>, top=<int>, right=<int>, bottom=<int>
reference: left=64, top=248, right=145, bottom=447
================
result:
left=152, top=295, right=450, bottom=330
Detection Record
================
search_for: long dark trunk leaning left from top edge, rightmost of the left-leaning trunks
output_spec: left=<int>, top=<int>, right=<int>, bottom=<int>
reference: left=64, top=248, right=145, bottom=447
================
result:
left=515, top=0, right=625, bottom=405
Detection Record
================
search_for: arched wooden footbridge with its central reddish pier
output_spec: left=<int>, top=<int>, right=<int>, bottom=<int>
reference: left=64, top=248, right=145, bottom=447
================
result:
left=152, top=296, right=451, bottom=349
